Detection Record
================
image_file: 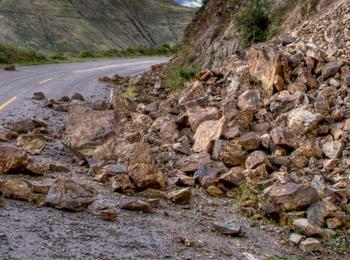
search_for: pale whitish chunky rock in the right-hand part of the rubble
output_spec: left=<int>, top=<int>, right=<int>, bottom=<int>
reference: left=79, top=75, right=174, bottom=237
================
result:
left=288, top=108, right=322, bottom=134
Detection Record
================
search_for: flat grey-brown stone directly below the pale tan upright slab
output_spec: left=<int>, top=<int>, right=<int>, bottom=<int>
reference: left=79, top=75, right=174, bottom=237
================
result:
left=176, top=153, right=212, bottom=172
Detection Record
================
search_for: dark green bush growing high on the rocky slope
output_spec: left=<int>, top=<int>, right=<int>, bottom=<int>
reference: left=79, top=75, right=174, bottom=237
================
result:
left=235, top=0, right=271, bottom=47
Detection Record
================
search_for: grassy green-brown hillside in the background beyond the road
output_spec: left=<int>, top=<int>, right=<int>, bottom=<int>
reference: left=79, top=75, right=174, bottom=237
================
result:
left=0, top=0, right=194, bottom=52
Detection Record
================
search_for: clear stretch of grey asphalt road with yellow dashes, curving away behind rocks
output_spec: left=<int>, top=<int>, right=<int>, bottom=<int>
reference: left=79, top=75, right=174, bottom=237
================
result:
left=0, top=58, right=168, bottom=121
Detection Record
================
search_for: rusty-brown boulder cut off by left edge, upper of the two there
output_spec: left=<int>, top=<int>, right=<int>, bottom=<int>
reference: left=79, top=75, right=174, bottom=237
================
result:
left=0, top=146, right=29, bottom=174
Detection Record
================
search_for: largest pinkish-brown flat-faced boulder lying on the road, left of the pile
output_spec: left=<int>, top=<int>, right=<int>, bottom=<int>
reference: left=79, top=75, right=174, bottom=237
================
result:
left=63, top=105, right=117, bottom=160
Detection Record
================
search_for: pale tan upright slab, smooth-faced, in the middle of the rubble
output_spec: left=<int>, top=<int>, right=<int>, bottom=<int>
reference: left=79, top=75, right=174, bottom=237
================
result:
left=193, top=117, right=225, bottom=153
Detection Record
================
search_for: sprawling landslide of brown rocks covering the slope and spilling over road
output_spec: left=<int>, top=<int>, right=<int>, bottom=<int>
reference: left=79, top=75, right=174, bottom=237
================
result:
left=0, top=0, right=350, bottom=259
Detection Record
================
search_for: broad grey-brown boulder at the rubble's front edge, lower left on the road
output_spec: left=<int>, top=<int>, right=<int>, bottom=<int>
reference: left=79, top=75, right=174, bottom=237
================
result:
left=44, top=178, right=96, bottom=212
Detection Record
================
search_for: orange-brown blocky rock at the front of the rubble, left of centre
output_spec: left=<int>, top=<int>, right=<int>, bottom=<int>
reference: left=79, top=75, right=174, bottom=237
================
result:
left=129, top=164, right=165, bottom=190
